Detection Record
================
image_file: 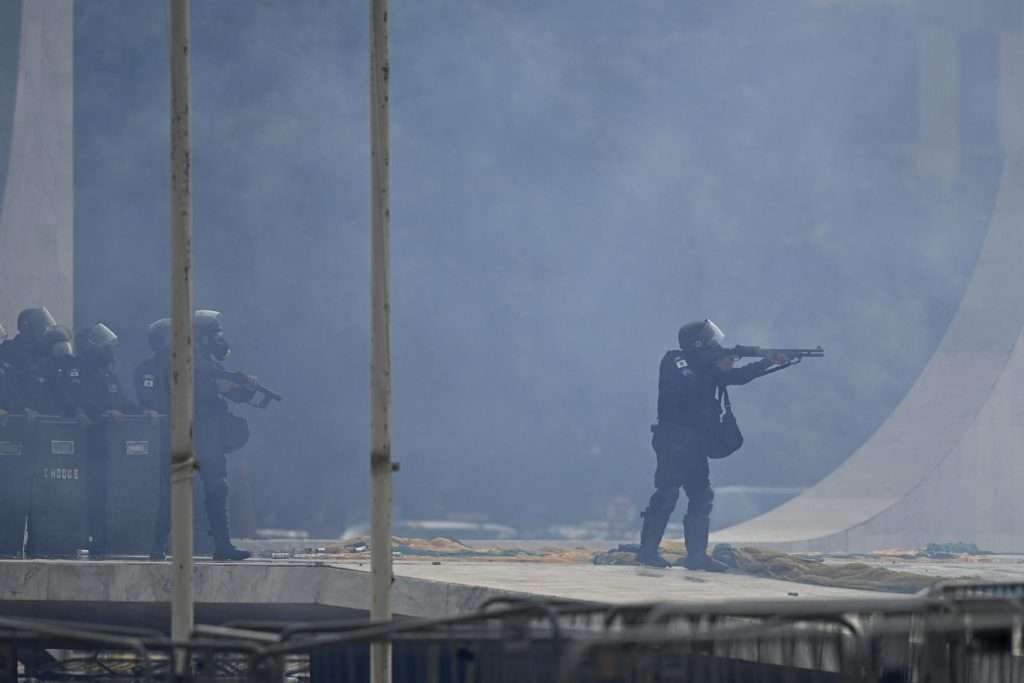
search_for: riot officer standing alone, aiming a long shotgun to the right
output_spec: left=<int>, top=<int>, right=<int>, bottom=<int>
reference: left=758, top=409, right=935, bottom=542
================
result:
left=638, top=319, right=787, bottom=571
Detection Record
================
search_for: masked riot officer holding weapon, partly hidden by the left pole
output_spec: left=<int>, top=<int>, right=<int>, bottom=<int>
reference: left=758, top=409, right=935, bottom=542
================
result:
left=194, top=310, right=253, bottom=560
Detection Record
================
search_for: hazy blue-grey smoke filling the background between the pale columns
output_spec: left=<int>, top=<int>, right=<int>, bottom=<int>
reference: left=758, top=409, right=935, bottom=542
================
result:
left=75, top=0, right=999, bottom=535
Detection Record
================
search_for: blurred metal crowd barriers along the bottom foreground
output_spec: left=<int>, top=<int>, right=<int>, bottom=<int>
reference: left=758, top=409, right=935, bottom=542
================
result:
left=6, top=584, right=1024, bottom=683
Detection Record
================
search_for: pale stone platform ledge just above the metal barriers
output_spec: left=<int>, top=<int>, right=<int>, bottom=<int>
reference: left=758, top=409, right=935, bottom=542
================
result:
left=0, top=559, right=888, bottom=631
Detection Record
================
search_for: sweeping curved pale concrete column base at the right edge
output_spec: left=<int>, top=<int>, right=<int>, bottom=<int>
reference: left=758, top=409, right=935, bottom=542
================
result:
left=712, top=31, right=1024, bottom=552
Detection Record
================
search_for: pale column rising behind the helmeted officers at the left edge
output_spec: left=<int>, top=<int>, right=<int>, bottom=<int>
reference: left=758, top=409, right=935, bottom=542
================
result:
left=0, top=0, right=74, bottom=332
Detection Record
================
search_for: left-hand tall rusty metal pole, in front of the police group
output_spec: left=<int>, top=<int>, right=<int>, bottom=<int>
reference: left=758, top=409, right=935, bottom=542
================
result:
left=170, top=0, right=196, bottom=651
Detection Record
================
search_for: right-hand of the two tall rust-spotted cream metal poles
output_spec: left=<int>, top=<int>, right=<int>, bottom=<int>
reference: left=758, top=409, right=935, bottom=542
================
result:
left=370, top=0, right=392, bottom=683
